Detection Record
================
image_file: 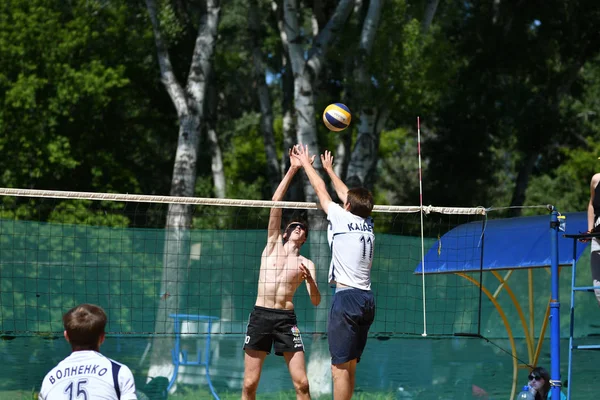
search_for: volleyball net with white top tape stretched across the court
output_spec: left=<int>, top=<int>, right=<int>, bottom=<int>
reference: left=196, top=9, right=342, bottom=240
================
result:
left=0, top=189, right=485, bottom=336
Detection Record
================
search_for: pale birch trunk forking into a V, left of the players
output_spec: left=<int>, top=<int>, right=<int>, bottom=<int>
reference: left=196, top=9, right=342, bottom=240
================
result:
left=146, top=0, right=220, bottom=377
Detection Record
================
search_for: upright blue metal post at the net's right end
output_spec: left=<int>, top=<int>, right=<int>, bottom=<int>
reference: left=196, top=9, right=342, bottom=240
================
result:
left=550, top=207, right=561, bottom=400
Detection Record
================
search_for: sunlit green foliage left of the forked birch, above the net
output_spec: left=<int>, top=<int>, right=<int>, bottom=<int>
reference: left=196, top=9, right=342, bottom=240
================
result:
left=0, top=0, right=173, bottom=203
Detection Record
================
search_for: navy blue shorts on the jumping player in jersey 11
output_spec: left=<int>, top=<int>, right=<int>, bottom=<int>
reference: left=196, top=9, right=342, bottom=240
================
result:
left=327, top=288, right=375, bottom=365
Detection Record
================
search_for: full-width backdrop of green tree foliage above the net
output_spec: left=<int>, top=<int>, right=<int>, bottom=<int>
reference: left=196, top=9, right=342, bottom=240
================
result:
left=0, top=0, right=600, bottom=218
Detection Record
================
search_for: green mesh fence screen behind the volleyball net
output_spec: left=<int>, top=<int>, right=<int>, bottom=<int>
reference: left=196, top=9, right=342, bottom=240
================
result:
left=0, top=213, right=598, bottom=400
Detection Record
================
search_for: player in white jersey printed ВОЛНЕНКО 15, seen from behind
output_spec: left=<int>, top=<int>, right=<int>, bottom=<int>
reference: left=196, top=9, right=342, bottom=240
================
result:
left=38, top=304, right=137, bottom=400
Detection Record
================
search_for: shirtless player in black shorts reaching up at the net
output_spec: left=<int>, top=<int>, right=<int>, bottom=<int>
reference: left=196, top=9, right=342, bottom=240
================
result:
left=242, top=150, right=321, bottom=400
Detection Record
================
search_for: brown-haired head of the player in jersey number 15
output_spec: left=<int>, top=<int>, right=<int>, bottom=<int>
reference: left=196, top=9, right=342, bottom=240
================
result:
left=63, top=304, right=107, bottom=351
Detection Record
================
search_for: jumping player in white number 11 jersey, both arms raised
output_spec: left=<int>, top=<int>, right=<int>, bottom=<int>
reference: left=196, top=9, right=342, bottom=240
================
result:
left=293, top=145, right=375, bottom=400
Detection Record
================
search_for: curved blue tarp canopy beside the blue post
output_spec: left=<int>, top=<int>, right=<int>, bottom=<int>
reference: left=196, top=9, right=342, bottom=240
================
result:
left=415, top=212, right=587, bottom=274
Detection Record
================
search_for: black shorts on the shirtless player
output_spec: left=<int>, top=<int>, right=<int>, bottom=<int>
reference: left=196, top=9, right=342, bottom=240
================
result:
left=244, top=306, right=304, bottom=356
